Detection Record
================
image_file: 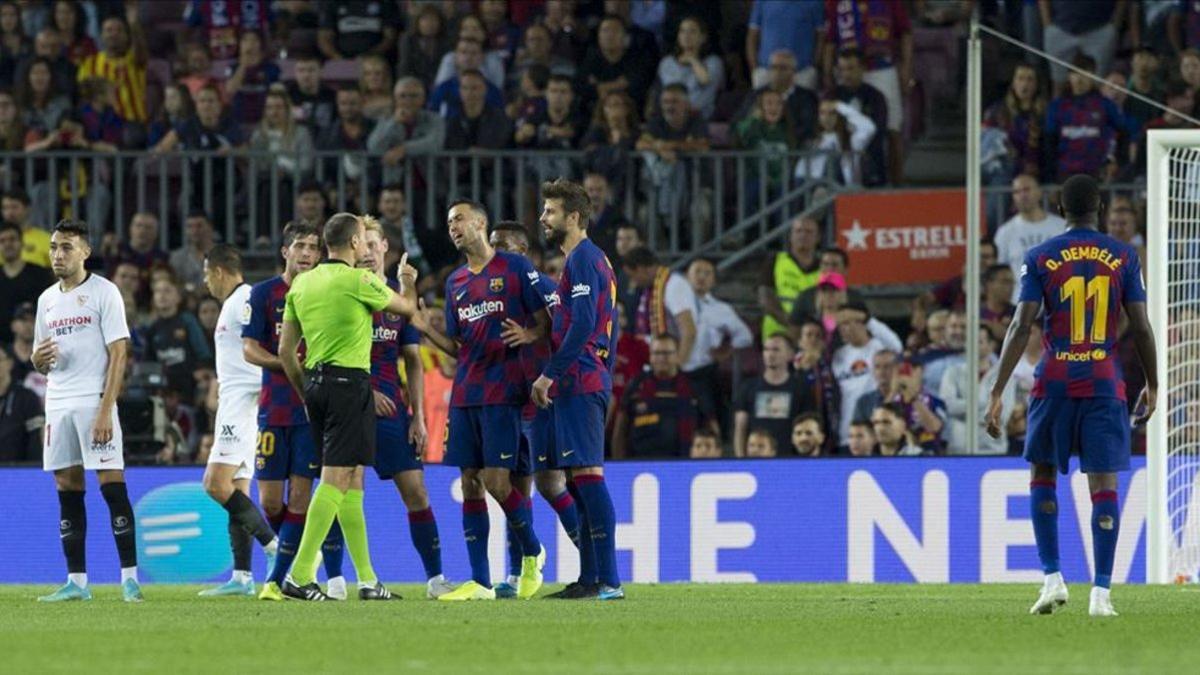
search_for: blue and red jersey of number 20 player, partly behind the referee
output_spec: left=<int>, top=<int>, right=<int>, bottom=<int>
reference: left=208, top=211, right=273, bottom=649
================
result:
left=241, top=271, right=308, bottom=426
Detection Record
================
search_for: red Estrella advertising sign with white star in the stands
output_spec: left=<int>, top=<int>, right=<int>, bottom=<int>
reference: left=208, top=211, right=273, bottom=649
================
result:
left=834, top=190, right=983, bottom=285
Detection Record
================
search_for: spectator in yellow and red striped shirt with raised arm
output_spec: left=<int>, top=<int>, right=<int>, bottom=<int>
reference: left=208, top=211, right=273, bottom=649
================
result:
left=76, top=14, right=148, bottom=123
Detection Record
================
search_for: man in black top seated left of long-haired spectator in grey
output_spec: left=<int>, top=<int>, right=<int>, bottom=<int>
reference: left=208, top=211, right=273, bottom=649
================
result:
left=580, top=14, right=654, bottom=114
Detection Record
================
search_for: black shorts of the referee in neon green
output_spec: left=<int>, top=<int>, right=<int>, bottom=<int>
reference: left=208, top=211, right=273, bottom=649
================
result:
left=305, top=364, right=376, bottom=467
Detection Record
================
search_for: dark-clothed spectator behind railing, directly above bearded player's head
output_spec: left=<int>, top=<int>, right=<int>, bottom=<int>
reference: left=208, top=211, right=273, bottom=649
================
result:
left=514, top=74, right=584, bottom=181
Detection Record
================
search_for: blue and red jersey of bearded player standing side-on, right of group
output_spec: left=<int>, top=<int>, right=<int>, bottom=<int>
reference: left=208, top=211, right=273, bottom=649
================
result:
left=545, top=239, right=617, bottom=395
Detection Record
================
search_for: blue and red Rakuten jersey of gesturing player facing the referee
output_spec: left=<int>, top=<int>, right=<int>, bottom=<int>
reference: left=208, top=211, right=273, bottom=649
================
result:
left=445, top=251, right=546, bottom=407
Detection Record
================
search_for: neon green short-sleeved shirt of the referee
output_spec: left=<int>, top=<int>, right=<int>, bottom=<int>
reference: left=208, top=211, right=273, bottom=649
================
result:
left=283, top=261, right=391, bottom=371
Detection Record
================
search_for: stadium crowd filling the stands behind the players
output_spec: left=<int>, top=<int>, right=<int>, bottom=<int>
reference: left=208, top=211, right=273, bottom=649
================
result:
left=0, top=0, right=1180, bottom=464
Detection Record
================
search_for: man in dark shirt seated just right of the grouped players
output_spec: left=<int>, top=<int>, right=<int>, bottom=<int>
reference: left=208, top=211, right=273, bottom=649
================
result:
left=612, top=335, right=718, bottom=459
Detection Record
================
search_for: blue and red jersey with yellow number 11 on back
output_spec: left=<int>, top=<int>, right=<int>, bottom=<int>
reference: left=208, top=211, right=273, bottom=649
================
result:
left=1020, top=227, right=1146, bottom=400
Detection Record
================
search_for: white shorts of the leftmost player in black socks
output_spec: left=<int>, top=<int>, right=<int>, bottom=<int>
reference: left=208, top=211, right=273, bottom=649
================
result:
left=42, top=405, right=125, bottom=471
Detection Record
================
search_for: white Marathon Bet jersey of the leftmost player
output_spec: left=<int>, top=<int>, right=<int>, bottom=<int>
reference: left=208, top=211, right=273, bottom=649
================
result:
left=34, top=274, right=130, bottom=410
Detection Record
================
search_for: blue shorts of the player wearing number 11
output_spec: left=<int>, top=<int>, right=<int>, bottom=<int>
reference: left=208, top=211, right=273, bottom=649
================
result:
left=1025, top=399, right=1130, bottom=474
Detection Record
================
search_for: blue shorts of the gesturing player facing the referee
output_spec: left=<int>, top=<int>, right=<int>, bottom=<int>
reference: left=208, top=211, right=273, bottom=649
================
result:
left=442, top=406, right=521, bottom=470
